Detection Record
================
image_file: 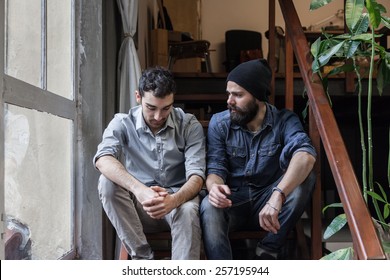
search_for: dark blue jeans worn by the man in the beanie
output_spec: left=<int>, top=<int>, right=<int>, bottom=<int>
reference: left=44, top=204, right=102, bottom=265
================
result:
left=200, top=172, right=315, bottom=260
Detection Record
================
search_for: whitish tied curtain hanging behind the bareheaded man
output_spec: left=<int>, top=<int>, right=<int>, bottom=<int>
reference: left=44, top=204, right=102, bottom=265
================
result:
left=117, top=0, right=141, bottom=113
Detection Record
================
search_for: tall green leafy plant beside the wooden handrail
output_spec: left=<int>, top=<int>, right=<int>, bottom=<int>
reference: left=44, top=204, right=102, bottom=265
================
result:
left=310, top=0, right=390, bottom=259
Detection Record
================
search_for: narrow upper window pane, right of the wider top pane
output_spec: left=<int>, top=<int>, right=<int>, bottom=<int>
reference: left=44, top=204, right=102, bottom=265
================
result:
left=47, top=0, right=73, bottom=99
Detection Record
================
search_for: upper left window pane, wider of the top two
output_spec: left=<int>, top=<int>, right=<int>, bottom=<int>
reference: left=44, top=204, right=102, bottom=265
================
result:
left=5, top=0, right=41, bottom=87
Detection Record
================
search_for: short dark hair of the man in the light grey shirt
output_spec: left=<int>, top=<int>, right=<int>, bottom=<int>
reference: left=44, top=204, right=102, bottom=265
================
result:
left=138, top=66, right=176, bottom=98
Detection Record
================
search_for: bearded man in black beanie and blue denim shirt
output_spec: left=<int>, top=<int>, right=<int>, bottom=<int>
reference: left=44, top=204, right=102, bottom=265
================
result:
left=200, top=59, right=316, bottom=259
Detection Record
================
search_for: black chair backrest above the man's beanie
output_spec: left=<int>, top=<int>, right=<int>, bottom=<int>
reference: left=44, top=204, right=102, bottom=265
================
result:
left=225, top=29, right=262, bottom=72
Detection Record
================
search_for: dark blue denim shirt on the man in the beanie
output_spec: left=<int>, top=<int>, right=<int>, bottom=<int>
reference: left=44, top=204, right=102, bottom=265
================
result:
left=207, top=103, right=316, bottom=190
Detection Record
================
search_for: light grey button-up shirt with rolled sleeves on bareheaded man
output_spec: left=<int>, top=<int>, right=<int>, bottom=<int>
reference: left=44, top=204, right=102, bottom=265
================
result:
left=93, top=106, right=206, bottom=191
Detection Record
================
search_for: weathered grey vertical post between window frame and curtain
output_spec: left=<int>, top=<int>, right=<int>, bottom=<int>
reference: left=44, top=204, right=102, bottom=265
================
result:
left=75, top=0, right=105, bottom=259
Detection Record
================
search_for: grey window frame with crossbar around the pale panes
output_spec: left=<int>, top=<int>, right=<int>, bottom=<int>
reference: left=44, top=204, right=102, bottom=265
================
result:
left=0, top=0, right=77, bottom=259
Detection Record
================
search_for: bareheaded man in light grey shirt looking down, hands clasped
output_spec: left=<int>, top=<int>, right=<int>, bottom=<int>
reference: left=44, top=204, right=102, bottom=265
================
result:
left=93, top=67, right=206, bottom=260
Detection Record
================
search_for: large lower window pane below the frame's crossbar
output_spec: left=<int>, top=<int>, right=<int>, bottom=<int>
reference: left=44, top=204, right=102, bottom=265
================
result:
left=4, top=104, right=74, bottom=260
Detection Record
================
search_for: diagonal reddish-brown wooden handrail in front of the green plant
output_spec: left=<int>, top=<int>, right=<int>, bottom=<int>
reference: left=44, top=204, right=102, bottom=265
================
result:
left=279, top=0, right=385, bottom=259
